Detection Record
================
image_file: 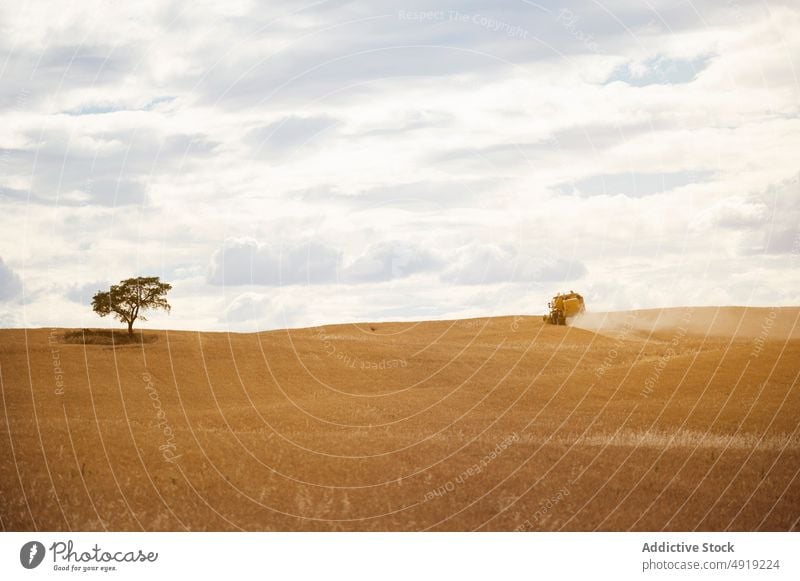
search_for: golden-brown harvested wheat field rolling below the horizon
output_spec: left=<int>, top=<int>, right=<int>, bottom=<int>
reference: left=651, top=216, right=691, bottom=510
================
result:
left=0, top=308, right=800, bottom=531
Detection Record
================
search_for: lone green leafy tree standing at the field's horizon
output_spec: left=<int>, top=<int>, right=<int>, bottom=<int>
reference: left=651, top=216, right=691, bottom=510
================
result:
left=92, top=276, right=172, bottom=337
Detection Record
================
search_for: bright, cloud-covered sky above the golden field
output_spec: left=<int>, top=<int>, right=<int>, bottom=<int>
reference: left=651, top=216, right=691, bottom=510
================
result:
left=0, top=0, right=800, bottom=331
